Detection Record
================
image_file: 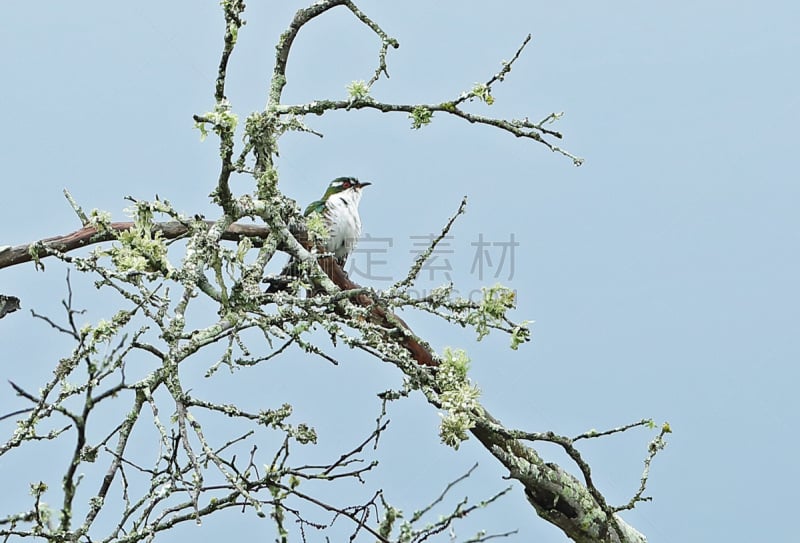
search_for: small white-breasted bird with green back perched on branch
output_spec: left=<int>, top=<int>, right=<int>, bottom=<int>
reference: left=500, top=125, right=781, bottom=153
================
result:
left=267, top=177, right=372, bottom=292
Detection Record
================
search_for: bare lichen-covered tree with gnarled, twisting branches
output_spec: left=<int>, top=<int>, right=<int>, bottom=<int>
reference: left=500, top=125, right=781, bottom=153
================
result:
left=0, top=0, right=670, bottom=542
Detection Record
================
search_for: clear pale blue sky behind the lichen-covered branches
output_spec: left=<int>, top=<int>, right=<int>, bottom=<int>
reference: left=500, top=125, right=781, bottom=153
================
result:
left=0, top=0, right=800, bottom=542
